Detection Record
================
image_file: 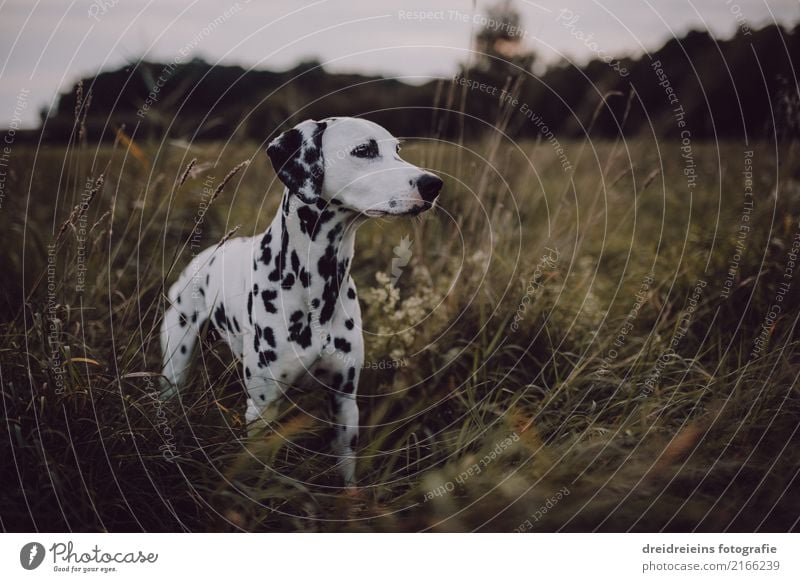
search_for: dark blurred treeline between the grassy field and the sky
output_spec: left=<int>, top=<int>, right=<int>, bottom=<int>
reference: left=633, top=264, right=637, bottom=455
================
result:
left=37, top=24, right=800, bottom=142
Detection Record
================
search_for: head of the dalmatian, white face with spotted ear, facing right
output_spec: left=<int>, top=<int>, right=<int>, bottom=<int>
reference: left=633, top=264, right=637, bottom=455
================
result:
left=267, top=117, right=442, bottom=217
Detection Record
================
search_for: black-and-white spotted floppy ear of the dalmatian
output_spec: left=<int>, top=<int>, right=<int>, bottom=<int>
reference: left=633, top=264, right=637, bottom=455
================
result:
left=267, top=119, right=327, bottom=204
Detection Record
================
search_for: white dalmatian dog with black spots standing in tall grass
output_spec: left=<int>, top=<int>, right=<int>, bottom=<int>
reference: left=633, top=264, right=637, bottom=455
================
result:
left=161, top=117, right=442, bottom=487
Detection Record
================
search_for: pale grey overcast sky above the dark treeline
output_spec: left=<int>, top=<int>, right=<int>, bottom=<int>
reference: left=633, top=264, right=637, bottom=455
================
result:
left=0, top=0, right=800, bottom=128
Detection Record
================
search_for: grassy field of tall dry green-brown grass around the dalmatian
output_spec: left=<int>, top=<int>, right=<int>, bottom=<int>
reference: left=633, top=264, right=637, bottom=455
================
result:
left=0, top=125, right=800, bottom=532
